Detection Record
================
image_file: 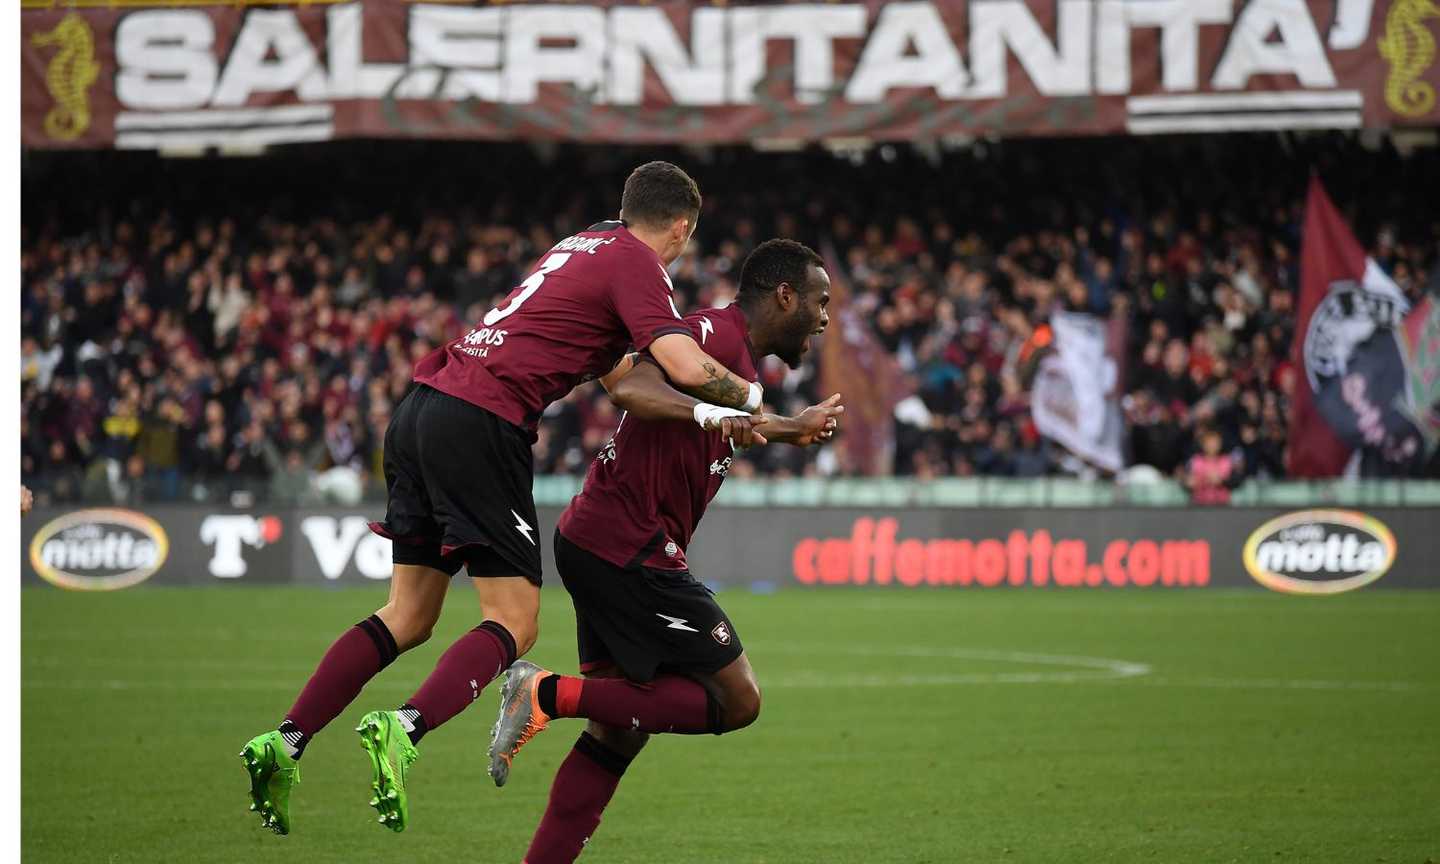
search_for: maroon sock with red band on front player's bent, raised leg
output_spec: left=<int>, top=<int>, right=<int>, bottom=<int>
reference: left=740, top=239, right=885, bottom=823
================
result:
left=554, top=675, right=719, bottom=734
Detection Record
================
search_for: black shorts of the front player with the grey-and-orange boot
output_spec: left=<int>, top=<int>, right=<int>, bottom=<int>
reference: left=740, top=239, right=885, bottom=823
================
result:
left=554, top=531, right=744, bottom=684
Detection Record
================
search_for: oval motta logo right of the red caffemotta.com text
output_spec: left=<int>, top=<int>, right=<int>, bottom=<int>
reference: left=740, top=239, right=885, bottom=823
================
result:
left=1244, top=510, right=1397, bottom=595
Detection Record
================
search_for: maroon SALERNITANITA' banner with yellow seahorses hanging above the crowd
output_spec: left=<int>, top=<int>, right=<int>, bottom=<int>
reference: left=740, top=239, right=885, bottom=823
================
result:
left=20, top=0, right=1440, bottom=148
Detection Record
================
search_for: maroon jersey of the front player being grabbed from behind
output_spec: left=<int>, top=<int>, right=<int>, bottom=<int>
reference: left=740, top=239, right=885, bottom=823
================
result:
left=560, top=305, right=759, bottom=570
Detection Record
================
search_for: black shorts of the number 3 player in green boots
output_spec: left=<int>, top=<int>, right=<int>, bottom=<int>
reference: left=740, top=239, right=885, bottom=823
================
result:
left=370, top=384, right=540, bottom=585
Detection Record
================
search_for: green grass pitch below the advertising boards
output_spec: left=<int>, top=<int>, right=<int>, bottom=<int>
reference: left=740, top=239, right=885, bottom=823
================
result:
left=22, top=586, right=1440, bottom=864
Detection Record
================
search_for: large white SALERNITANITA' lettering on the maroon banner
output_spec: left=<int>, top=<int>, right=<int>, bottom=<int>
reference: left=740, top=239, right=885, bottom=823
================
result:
left=115, top=0, right=1347, bottom=118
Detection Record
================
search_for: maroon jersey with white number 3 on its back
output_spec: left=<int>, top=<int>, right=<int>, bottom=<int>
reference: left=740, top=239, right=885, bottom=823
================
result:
left=415, top=222, right=688, bottom=435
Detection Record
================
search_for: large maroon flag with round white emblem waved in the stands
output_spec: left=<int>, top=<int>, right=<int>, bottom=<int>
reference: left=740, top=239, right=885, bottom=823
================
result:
left=1287, top=179, right=1418, bottom=477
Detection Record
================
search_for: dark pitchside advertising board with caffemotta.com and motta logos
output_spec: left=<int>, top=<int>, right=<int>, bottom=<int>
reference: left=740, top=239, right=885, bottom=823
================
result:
left=20, top=505, right=1440, bottom=595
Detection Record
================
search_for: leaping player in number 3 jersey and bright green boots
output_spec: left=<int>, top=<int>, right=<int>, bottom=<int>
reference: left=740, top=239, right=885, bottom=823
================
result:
left=240, top=161, right=763, bottom=834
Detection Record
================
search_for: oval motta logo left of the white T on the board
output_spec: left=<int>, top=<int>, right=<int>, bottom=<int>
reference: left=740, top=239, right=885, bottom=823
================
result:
left=30, top=508, right=170, bottom=590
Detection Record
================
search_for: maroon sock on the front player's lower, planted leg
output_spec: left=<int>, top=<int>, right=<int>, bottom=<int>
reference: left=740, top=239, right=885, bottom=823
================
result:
left=524, top=732, right=631, bottom=864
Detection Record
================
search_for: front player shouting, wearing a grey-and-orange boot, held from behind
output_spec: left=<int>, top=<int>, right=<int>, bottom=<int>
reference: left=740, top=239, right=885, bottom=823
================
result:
left=490, top=240, right=844, bottom=864
